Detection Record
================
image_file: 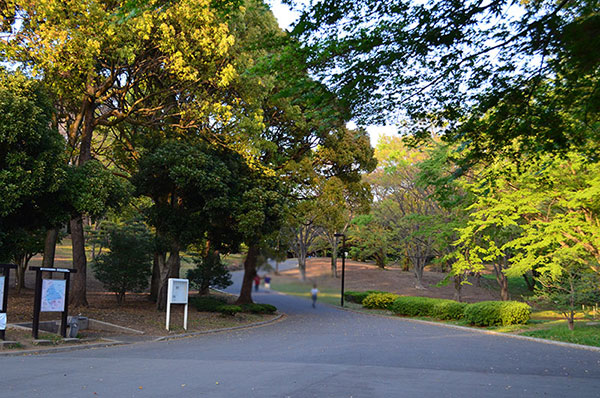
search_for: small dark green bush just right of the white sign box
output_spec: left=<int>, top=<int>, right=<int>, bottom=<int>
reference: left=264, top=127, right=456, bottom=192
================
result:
left=186, top=251, right=233, bottom=294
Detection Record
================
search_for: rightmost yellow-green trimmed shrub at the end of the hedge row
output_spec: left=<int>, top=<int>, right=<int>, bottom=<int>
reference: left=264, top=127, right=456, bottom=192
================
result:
left=464, top=301, right=531, bottom=326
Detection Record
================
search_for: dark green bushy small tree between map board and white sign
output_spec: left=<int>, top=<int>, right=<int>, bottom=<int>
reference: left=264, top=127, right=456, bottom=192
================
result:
left=92, top=223, right=152, bottom=304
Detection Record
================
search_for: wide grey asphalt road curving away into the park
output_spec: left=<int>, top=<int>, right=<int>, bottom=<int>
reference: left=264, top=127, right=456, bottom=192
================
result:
left=0, top=264, right=600, bottom=398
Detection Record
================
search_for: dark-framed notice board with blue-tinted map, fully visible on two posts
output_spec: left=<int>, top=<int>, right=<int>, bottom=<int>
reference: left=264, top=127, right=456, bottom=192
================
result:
left=29, top=267, right=77, bottom=339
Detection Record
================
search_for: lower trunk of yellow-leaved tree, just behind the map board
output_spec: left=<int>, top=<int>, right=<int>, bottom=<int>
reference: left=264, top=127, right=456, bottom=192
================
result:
left=69, top=214, right=88, bottom=307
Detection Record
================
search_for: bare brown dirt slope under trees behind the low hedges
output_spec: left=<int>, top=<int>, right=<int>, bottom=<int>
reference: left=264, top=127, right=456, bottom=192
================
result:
left=274, top=258, right=500, bottom=302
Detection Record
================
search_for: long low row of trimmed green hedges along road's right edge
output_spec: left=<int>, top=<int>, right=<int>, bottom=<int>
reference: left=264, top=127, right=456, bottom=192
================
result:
left=356, top=292, right=531, bottom=326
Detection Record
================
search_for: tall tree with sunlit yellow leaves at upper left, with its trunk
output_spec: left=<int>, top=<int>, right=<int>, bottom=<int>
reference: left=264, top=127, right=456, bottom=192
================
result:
left=0, top=0, right=241, bottom=305
